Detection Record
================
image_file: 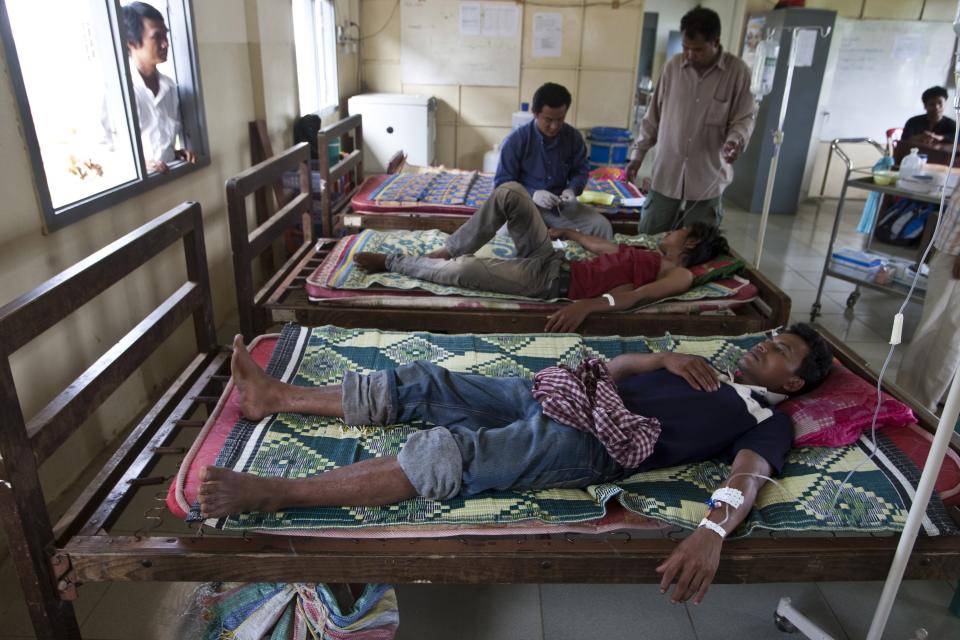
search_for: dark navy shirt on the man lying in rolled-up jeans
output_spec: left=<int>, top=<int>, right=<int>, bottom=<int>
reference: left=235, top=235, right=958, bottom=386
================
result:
left=617, top=369, right=793, bottom=473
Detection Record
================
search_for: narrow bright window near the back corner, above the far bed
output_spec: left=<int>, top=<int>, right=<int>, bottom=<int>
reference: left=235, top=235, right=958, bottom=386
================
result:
left=293, top=0, right=340, bottom=116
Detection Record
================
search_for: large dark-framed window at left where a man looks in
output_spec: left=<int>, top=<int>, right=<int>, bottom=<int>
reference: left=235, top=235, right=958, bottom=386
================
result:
left=0, top=0, right=209, bottom=231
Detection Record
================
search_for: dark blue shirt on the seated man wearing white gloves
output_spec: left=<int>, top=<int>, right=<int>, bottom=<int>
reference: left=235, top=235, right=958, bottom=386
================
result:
left=493, top=120, right=590, bottom=195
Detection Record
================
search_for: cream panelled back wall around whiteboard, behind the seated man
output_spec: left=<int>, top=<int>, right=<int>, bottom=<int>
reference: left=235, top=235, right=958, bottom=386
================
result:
left=360, top=0, right=644, bottom=169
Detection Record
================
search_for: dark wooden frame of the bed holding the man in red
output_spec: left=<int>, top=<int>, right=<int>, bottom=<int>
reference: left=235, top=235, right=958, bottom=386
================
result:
left=226, top=133, right=790, bottom=340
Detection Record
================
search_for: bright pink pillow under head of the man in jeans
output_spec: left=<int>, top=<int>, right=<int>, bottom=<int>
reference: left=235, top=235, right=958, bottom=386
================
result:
left=778, top=361, right=916, bottom=447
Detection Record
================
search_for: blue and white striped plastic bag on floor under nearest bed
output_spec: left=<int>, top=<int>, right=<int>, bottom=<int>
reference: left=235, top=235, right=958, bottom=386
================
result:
left=202, top=582, right=400, bottom=640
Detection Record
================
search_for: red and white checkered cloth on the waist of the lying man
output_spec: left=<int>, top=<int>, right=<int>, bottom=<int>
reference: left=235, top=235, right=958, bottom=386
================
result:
left=533, top=358, right=660, bottom=469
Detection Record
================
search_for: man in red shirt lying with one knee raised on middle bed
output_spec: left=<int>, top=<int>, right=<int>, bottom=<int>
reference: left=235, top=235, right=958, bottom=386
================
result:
left=354, top=182, right=729, bottom=332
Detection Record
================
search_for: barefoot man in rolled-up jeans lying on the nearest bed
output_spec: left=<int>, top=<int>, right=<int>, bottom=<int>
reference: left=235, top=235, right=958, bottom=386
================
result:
left=199, top=324, right=832, bottom=603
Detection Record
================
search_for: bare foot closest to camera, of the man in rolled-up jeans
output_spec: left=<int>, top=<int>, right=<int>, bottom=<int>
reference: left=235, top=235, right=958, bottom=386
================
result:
left=199, top=465, right=282, bottom=518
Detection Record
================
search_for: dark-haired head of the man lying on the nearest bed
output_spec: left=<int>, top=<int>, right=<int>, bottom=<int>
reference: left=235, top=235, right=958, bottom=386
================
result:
left=737, top=323, right=833, bottom=395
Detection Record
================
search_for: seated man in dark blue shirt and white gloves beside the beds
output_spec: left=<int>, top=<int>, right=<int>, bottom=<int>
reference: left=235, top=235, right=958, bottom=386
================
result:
left=494, top=82, right=613, bottom=240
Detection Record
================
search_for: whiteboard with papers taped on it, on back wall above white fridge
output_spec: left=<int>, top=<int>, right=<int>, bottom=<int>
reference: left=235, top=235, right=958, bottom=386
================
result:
left=400, top=0, right=523, bottom=87
